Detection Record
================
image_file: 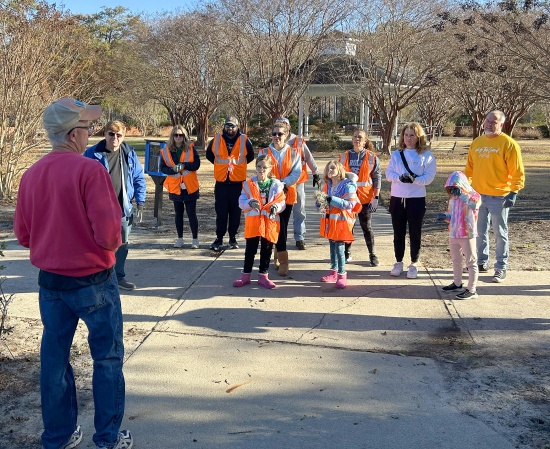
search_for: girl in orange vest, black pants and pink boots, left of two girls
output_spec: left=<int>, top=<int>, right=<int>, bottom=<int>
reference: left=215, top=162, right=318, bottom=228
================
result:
left=233, top=155, right=285, bottom=288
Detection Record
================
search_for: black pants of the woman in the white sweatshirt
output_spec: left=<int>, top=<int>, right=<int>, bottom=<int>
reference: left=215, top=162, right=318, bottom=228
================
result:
left=389, top=196, right=426, bottom=263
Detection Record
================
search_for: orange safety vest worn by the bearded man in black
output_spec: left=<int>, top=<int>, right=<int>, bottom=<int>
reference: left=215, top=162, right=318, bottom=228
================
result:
left=212, top=134, right=248, bottom=182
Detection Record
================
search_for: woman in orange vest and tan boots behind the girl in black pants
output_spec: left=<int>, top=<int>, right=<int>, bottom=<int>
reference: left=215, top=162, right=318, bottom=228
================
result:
left=258, top=122, right=302, bottom=276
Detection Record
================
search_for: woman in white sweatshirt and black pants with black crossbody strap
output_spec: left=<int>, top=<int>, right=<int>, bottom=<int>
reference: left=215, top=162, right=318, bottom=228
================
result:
left=386, top=122, right=436, bottom=279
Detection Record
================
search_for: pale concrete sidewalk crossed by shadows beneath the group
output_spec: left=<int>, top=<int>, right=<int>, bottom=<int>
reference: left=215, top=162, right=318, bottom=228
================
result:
left=3, top=183, right=550, bottom=449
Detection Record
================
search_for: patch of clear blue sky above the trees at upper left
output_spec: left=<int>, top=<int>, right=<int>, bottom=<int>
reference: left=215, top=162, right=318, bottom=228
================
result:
left=48, top=0, right=199, bottom=15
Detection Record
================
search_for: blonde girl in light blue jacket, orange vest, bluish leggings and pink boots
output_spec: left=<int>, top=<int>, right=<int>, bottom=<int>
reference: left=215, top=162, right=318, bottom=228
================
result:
left=317, top=161, right=361, bottom=288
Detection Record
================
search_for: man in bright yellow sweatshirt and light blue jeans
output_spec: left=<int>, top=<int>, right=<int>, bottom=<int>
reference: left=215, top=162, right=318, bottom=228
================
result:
left=464, top=111, right=525, bottom=282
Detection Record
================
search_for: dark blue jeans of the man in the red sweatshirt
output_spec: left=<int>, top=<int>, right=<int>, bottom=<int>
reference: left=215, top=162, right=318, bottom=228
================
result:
left=39, top=274, right=125, bottom=449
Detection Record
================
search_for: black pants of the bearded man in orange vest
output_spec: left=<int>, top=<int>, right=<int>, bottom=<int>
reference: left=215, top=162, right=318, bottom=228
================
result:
left=214, top=182, right=242, bottom=240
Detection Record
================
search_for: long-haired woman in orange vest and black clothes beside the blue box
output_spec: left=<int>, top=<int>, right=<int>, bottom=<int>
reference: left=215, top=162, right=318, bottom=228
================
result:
left=160, top=125, right=201, bottom=249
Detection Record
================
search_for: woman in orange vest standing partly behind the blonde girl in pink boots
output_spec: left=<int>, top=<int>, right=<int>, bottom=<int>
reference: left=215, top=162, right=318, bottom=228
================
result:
left=340, top=129, right=382, bottom=267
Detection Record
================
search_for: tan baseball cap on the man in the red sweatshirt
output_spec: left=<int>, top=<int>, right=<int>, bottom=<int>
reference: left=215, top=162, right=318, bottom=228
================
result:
left=42, top=98, right=101, bottom=134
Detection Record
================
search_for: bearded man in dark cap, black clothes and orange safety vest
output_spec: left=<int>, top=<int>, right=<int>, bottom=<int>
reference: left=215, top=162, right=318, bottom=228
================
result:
left=206, top=117, right=254, bottom=251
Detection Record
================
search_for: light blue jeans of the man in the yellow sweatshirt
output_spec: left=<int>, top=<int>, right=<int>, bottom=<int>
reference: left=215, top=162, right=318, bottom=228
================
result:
left=477, top=195, right=510, bottom=270
